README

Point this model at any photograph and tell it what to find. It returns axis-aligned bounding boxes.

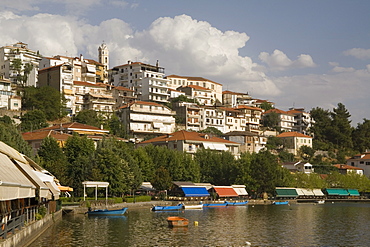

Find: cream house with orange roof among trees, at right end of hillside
[277,131,312,155]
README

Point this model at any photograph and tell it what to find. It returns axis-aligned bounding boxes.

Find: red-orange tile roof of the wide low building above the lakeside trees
[141,130,238,144]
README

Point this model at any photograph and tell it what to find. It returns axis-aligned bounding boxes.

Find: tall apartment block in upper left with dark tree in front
[0,42,41,86]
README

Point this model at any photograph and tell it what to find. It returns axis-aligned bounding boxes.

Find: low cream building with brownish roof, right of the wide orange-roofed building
[224,131,267,153]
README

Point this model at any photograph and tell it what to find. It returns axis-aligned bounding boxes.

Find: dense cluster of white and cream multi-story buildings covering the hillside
[0,42,314,151]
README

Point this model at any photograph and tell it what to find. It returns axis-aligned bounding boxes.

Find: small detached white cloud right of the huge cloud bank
[259,50,316,71]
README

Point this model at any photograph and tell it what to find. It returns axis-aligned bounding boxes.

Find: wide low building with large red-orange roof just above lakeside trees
[137,130,240,157]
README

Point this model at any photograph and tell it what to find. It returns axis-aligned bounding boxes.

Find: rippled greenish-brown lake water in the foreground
[30,203,370,247]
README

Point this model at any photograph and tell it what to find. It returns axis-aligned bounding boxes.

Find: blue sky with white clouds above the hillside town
[0,0,370,127]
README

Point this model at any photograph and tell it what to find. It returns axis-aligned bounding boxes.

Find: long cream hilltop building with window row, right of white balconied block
[167,75,222,105]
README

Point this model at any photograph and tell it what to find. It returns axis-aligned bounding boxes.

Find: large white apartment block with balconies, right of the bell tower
[110,61,169,103]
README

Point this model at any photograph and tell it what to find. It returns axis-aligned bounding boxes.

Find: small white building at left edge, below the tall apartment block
[0,76,22,111]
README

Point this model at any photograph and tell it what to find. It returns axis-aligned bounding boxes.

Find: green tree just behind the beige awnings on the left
[37,137,68,184]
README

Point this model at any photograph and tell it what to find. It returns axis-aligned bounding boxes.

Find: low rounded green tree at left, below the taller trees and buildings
[20,110,49,132]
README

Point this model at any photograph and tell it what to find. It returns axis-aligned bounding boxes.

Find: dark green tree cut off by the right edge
[352,118,370,153]
